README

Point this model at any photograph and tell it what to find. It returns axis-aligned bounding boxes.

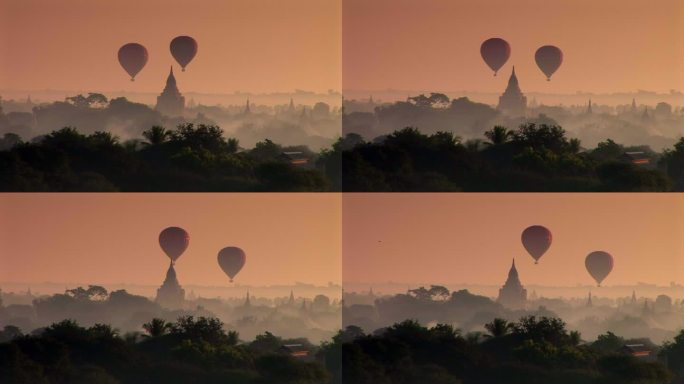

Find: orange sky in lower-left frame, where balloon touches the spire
[0,193,341,286]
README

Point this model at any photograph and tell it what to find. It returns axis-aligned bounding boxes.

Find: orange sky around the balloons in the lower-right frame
[342,193,684,286]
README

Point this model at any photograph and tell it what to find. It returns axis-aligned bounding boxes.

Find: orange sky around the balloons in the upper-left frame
[0,0,341,93]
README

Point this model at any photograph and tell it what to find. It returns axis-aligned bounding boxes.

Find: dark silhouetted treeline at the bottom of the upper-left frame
[0,124,329,191]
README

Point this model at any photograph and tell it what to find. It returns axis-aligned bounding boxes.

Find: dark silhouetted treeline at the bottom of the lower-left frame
[0,316,329,384]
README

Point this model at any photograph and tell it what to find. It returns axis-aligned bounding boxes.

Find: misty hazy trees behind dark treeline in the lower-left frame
[0,285,341,343]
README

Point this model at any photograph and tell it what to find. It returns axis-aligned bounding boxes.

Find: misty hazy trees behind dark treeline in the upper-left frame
[0,93,340,150]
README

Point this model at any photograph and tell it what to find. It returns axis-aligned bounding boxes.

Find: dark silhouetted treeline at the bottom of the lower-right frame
[329,316,684,384]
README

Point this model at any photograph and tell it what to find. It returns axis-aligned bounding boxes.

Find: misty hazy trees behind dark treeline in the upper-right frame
[342,92,684,151]
